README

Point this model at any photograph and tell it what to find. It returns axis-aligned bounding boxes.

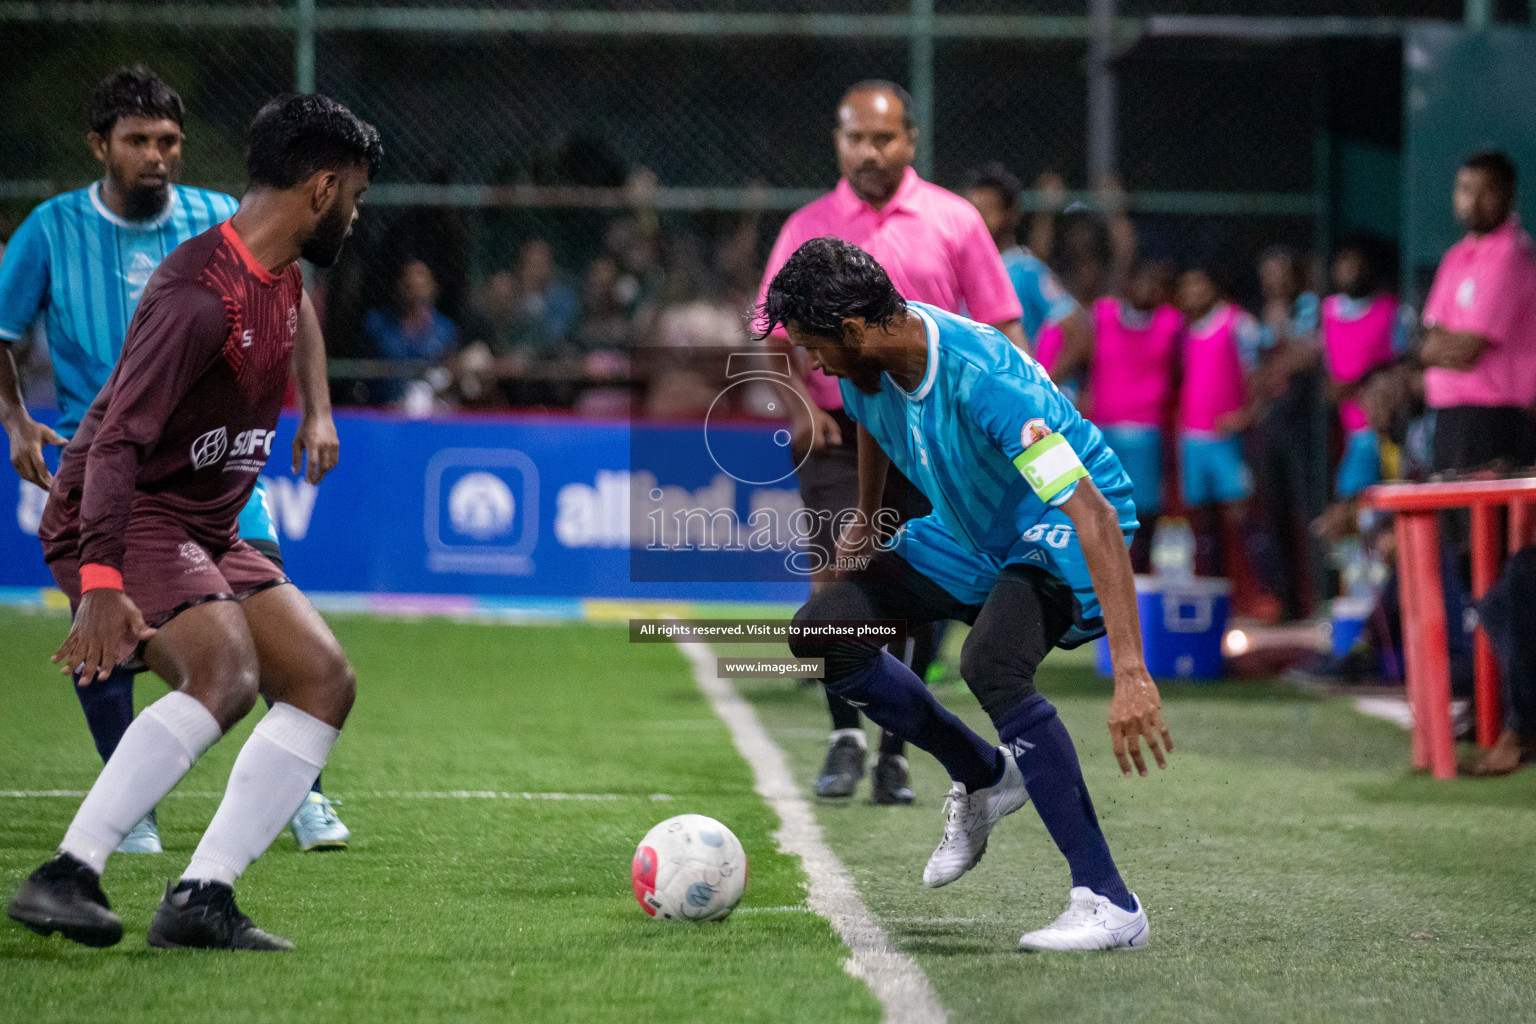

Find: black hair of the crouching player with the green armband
[756,235,906,339]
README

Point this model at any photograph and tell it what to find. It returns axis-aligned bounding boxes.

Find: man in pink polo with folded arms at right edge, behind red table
[1419,154,1536,470]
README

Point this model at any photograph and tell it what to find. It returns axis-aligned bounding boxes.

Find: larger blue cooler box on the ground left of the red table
[1095,576,1232,680]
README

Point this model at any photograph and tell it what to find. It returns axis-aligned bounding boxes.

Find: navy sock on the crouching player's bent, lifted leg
[833,651,1003,792]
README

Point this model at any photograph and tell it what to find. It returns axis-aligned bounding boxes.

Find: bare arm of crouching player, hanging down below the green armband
[1061,479,1174,775]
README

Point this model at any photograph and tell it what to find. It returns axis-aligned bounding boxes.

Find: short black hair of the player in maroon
[246,94,384,189]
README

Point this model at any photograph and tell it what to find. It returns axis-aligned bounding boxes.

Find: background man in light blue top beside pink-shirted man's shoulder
[962,163,1094,402]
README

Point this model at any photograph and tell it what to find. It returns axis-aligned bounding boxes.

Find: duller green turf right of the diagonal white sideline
[740,635,1536,1024]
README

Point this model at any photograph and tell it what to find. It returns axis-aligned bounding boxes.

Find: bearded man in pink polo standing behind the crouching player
[757,80,1028,803]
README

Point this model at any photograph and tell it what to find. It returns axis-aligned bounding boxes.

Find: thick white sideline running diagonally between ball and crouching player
[677,643,949,1024]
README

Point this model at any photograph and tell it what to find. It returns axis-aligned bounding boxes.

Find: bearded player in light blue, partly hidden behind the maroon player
[0,66,349,854]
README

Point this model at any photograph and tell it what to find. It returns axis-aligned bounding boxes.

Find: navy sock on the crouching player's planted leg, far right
[997,694,1135,910]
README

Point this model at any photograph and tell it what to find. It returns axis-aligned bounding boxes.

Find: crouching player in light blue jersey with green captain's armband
[759,238,1172,950]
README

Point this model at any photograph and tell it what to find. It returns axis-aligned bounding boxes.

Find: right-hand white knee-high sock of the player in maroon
[181,703,339,886]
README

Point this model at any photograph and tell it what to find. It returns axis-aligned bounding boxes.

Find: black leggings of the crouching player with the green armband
[790,551,1074,725]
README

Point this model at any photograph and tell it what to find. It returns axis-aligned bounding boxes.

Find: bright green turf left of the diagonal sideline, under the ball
[0,609,880,1024]
